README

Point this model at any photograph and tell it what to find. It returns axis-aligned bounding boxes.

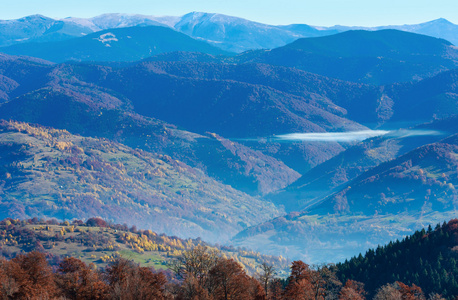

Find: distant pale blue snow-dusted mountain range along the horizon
[0,12,458,53]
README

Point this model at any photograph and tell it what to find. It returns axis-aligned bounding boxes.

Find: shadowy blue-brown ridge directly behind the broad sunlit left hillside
[0,53,299,194]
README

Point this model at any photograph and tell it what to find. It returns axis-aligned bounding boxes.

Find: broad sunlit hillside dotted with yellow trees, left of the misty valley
[0,122,280,241]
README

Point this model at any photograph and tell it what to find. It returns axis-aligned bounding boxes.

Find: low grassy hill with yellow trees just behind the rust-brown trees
[0,218,288,274]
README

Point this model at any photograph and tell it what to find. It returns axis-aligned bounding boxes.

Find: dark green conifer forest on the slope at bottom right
[337,219,458,299]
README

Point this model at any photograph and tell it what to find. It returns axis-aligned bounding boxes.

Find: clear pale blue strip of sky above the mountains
[0,0,458,26]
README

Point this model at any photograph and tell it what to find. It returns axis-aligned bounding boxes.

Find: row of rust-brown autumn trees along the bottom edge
[0,246,441,300]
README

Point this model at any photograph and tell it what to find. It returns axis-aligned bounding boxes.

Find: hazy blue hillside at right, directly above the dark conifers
[233,135,458,261]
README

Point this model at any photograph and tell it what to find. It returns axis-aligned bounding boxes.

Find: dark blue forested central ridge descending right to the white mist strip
[38,61,370,172]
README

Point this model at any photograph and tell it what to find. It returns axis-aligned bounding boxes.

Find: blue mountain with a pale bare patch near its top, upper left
[0,26,229,63]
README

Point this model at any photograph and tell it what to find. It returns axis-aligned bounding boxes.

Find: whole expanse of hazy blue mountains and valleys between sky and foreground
[0,13,458,262]
